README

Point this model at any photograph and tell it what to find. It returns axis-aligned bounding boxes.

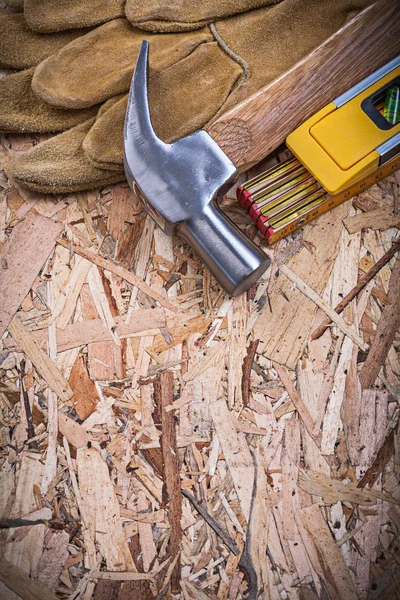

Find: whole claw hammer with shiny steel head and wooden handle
[124,0,400,296]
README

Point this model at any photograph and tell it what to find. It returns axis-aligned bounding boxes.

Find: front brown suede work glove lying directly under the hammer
[0,0,370,192]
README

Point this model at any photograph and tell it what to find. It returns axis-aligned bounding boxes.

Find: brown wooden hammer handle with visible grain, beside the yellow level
[206,0,400,171]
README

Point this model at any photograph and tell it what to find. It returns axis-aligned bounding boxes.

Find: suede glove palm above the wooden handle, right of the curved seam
[215,0,372,114]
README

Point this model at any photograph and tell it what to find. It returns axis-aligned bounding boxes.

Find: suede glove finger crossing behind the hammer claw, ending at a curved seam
[83,42,242,169]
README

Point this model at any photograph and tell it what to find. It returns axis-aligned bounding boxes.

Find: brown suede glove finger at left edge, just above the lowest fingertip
[0,68,99,133]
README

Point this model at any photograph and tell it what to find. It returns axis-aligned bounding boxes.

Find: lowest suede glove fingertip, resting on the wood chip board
[8,118,125,194]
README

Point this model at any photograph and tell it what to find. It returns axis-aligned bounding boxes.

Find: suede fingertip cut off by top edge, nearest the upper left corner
[24,0,125,33]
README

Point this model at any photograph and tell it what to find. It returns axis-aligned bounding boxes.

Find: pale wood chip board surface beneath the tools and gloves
[0,136,400,600]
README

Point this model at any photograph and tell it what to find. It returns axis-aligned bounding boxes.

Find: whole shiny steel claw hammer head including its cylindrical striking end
[124,41,270,296]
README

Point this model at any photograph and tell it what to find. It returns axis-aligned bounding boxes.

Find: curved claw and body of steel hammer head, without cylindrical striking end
[124,41,237,235]
